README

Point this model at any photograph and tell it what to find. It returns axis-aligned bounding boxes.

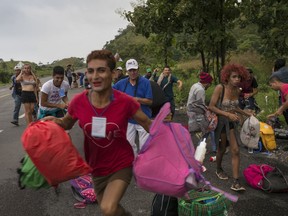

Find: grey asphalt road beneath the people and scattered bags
[0,79,288,216]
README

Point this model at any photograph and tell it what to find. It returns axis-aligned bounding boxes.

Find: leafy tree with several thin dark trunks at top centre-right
[176,0,240,77]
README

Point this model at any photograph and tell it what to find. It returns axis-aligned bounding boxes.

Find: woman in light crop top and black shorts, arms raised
[16,64,38,126]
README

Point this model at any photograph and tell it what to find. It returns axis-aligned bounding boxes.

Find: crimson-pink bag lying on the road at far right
[243,164,274,190]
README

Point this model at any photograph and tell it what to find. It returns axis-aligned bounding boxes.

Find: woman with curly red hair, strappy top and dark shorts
[209,64,251,191]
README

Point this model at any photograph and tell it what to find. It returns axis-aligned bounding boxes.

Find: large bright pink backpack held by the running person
[133,103,237,201]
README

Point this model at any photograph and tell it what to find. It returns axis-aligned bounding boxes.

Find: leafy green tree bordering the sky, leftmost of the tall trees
[124,0,182,65]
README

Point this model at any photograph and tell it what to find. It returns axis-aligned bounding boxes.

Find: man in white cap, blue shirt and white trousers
[113,59,153,155]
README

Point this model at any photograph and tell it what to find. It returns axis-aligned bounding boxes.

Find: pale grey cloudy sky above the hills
[0,0,135,64]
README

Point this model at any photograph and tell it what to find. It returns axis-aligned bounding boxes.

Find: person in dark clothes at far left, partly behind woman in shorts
[9,65,22,126]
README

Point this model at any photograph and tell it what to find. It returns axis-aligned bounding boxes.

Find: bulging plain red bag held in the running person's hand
[21,121,92,186]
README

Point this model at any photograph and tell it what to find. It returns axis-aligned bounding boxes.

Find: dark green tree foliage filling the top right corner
[241,0,288,59]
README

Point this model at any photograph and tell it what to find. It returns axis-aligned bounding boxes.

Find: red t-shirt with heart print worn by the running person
[68,90,140,176]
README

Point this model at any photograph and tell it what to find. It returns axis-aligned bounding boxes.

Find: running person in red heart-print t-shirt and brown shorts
[43,50,151,216]
